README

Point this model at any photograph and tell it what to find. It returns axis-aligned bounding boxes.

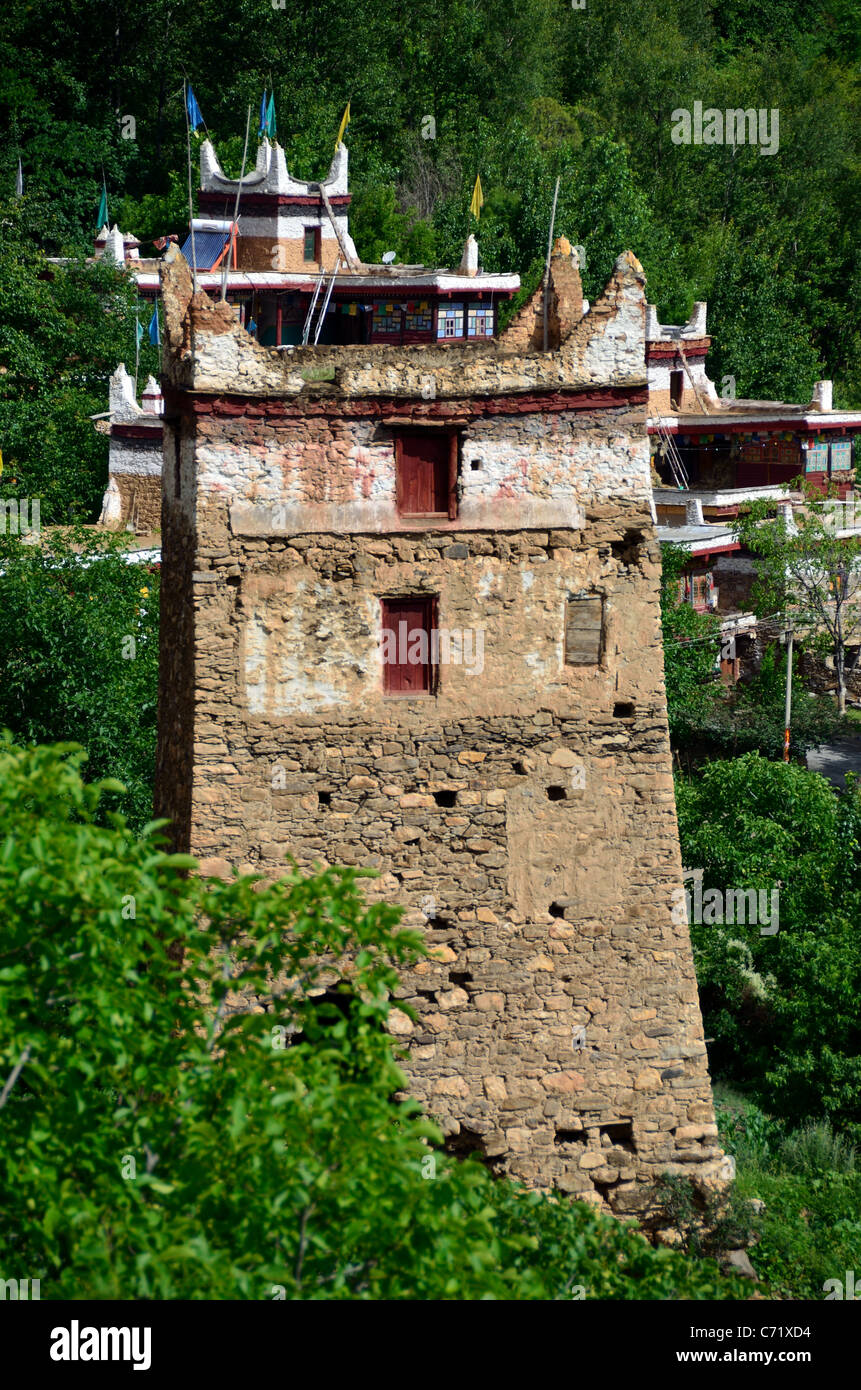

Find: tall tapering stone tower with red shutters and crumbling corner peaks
[157,247,725,1212]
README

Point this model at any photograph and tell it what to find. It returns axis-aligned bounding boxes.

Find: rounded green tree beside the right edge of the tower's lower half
[676,753,861,1137]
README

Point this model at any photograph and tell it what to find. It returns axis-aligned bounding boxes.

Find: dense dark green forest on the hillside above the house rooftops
[0,0,861,406]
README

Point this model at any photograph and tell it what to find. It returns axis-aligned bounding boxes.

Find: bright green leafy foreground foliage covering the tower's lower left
[0,742,739,1300]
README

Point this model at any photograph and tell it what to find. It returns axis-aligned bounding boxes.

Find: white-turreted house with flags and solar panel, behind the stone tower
[95,138,520,525]
